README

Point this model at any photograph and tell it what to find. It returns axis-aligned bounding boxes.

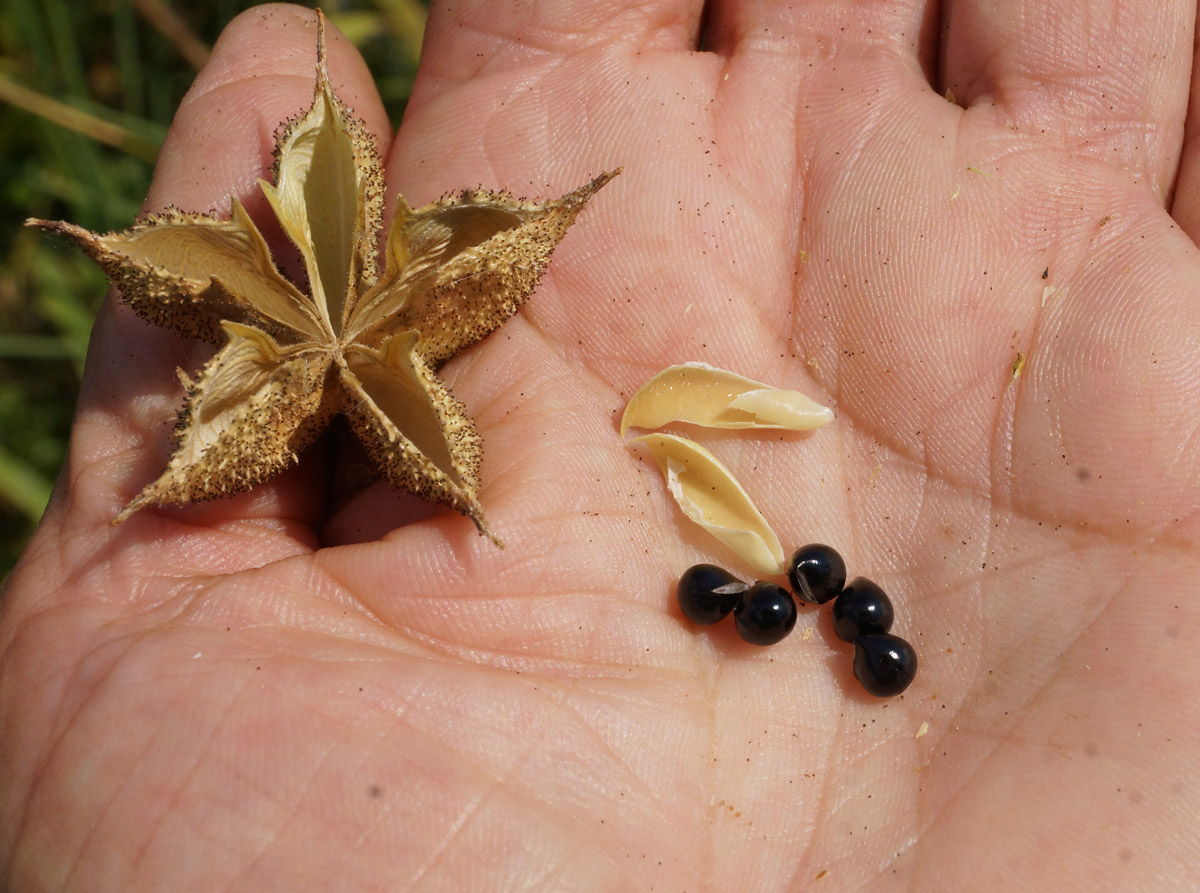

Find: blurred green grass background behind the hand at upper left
[0,0,427,580]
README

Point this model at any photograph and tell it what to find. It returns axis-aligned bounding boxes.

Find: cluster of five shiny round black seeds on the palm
[676,543,917,697]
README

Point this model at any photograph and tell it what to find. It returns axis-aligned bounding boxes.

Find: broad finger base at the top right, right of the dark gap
[944,0,1195,200]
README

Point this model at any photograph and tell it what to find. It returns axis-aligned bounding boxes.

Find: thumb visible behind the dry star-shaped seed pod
[58,5,389,544]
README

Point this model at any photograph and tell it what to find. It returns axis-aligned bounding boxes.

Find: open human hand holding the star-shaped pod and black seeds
[0,0,1200,891]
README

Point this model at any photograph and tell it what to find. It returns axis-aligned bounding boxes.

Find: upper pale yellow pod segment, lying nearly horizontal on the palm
[620,362,833,437]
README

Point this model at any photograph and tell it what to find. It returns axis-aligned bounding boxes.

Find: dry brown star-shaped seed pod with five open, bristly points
[29,13,618,543]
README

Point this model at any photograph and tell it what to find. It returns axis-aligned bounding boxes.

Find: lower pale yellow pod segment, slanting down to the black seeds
[630,434,784,575]
